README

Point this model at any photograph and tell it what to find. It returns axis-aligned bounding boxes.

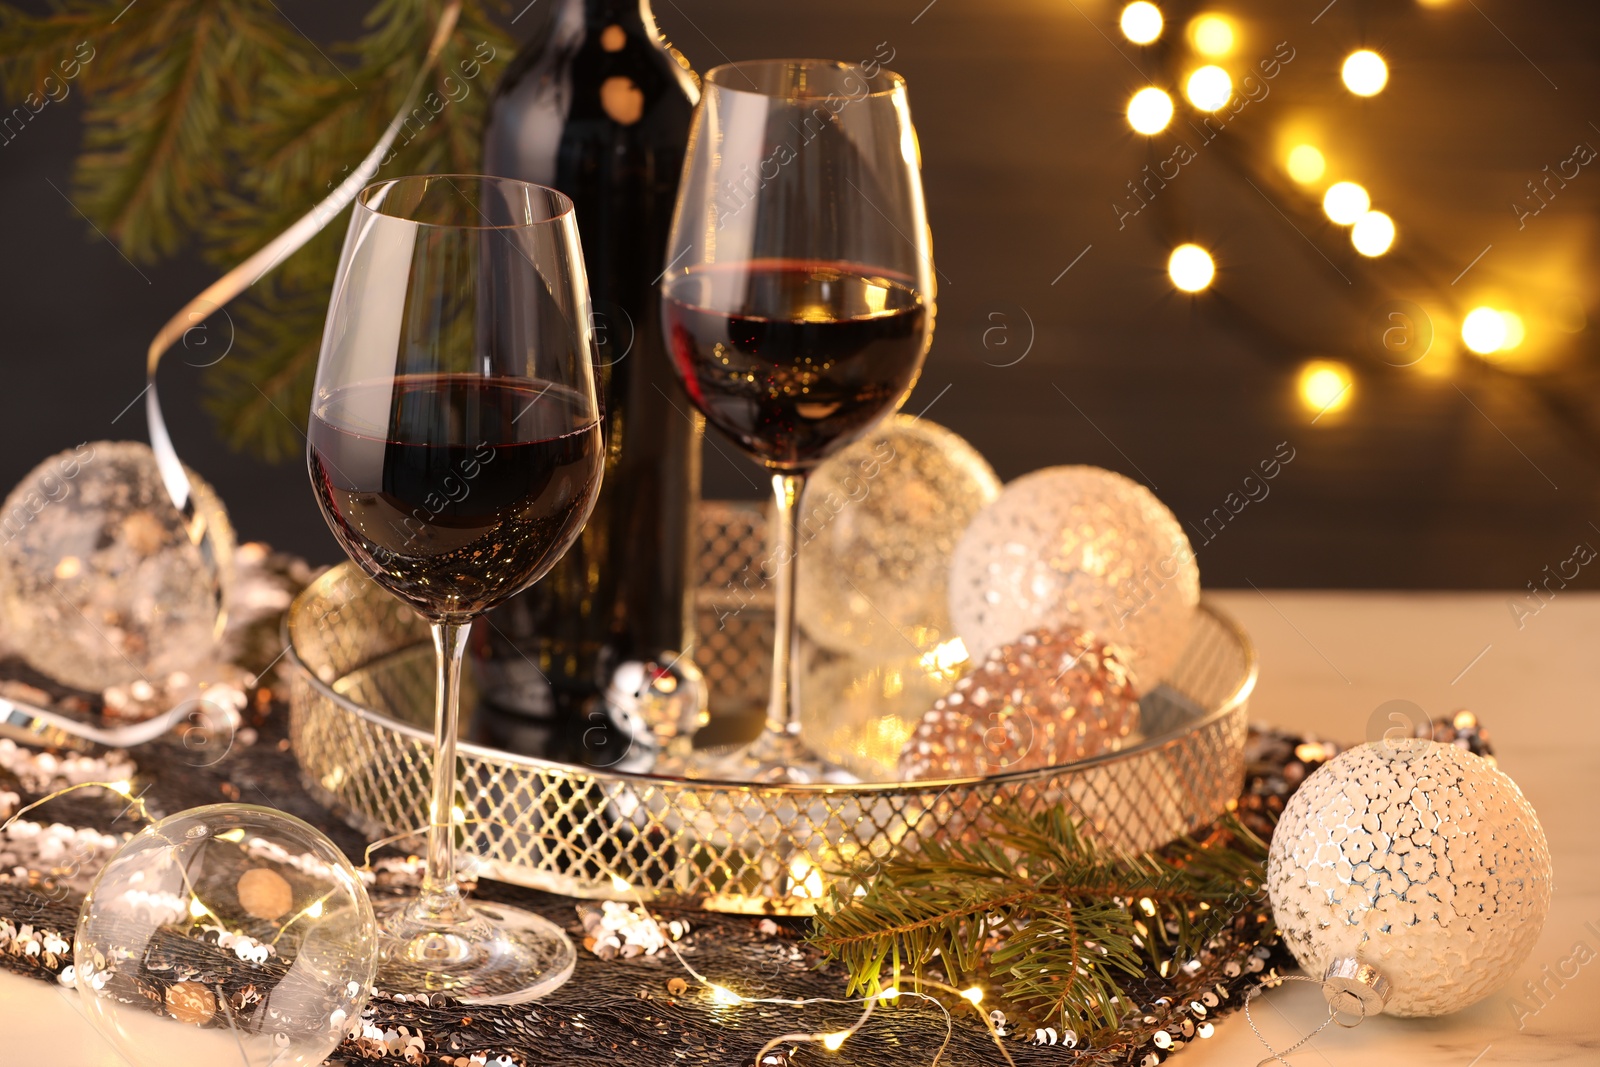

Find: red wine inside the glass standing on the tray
[662,259,928,470]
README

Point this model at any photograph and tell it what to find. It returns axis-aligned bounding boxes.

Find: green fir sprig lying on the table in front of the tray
[811,808,1266,1030]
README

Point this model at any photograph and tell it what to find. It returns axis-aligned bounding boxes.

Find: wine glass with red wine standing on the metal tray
[661,59,934,782]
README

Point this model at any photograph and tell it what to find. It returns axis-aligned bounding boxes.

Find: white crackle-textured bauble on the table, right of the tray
[1267,741,1550,1016]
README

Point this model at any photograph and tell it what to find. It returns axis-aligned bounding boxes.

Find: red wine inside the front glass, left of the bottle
[307,374,603,619]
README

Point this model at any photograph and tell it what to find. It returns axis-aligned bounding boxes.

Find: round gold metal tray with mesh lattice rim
[286,502,1256,915]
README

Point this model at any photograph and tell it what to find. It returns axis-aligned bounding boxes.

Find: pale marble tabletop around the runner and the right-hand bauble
[0,590,1600,1067]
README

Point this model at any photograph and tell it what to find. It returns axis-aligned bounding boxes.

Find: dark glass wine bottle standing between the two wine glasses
[472,0,701,766]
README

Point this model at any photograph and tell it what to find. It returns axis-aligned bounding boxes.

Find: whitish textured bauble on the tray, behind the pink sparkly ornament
[950,467,1200,694]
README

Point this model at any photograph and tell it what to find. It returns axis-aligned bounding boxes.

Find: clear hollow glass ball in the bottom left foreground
[72,805,378,1067]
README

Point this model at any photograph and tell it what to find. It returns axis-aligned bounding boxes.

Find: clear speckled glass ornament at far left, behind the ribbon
[0,442,234,691]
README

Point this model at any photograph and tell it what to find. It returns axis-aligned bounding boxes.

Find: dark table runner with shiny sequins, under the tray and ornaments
[0,704,1388,1067]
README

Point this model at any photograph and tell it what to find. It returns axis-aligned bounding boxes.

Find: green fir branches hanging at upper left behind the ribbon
[0,0,515,459]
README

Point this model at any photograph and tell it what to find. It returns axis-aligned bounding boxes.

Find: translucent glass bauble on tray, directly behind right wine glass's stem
[797,414,1000,659]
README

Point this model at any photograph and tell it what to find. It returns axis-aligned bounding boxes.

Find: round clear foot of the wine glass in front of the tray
[374,897,578,1005]
